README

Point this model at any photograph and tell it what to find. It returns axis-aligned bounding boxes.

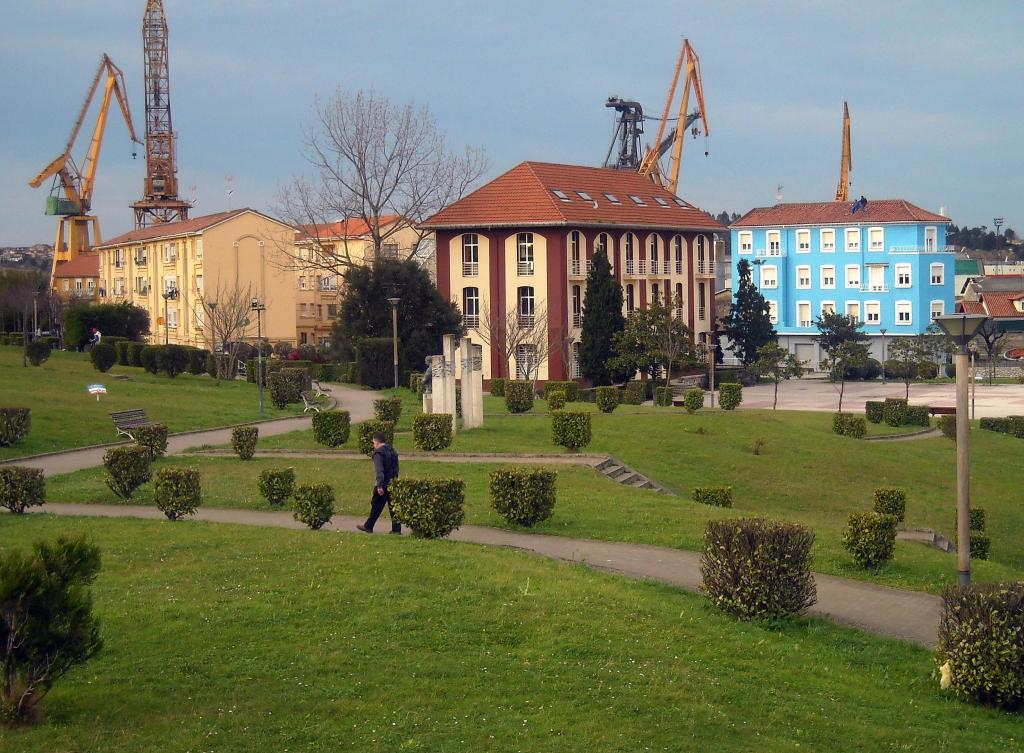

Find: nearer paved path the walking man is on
[38,503,941,649]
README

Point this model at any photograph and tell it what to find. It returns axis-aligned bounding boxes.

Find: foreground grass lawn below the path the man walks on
[0,515,1022,753]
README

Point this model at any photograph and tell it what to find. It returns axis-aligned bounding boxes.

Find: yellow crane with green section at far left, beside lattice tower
[29,54,141,280]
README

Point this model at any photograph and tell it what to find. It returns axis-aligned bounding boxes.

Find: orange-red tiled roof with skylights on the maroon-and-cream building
[422,162,724,231]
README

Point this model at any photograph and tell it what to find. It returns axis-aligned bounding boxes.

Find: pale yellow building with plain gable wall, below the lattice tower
[96,209,299,348]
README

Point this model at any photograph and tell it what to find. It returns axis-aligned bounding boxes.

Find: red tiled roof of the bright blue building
[729,199,951,227]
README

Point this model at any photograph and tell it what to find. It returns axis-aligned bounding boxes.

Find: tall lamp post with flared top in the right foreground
[935,313,988,586]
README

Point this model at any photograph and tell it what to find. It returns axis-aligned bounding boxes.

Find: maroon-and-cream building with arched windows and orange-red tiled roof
[423,162,725,381]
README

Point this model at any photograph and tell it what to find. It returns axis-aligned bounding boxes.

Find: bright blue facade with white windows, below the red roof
[731,216,955,339]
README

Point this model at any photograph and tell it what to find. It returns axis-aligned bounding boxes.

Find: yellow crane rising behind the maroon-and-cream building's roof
[640,39,711,194]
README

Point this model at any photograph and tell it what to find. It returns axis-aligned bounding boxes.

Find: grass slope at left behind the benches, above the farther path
[0,346,301,460]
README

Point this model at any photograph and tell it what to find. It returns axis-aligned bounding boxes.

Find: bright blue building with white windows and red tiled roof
[730,199,955,369]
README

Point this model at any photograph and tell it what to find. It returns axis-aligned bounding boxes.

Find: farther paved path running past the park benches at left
[0,384,380,475]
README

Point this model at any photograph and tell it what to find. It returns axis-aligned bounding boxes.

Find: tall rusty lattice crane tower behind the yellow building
[131,0,191,227]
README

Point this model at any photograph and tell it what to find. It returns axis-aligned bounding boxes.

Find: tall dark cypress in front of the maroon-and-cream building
[580,251,626,385]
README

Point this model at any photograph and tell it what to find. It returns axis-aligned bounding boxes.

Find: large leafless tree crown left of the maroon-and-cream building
[275,89,488,275]
